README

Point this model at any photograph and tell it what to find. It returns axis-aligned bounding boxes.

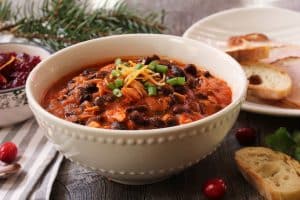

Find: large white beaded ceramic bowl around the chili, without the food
[26,34,247,184]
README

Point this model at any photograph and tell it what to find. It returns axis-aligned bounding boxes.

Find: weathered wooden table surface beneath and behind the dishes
[51,0,300,200]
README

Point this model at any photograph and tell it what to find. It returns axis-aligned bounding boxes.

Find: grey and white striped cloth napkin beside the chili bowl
[0,118,63,200]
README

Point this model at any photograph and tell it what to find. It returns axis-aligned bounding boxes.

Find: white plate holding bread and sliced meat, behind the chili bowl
[183,7,300,116]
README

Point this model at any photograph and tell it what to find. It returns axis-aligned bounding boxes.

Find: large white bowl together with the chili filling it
[26,34,247,184]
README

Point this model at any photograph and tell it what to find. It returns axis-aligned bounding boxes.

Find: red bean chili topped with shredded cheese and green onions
[43,55,232,130]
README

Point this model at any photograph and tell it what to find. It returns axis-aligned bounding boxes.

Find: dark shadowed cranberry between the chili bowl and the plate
[235,127,256,146]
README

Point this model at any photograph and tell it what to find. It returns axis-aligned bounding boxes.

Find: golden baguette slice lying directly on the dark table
[235,147,300,200]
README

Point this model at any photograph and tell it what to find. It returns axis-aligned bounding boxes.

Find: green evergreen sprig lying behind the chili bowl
[0,0,165,50]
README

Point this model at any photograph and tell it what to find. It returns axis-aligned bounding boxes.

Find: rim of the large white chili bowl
[25,33,247,137]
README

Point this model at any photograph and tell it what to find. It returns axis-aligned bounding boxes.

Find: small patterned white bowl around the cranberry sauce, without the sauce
[0,43,50,127]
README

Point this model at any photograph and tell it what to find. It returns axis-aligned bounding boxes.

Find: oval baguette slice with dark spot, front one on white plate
[241,62,292,100]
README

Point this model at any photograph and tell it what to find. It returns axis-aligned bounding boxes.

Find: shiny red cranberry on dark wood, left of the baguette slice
[202,178,226,199]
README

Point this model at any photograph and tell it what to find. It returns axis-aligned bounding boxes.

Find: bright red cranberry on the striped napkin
[0,142,18,163]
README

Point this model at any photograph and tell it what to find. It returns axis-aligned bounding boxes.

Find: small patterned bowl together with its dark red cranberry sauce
[0,43,50,127]
